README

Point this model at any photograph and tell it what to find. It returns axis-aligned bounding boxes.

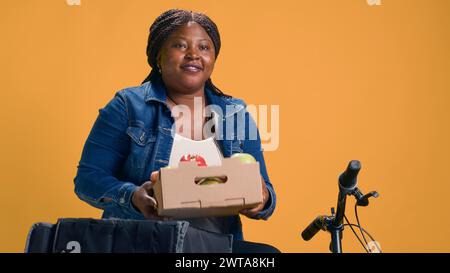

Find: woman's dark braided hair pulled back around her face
[142,9,231,97]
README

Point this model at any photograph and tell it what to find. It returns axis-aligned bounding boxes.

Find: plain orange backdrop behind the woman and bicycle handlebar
[0,0,450,252]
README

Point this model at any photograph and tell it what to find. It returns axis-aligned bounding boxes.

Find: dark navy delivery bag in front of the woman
[25,218,233,253]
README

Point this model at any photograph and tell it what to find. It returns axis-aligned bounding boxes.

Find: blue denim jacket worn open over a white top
[74,77,276,240]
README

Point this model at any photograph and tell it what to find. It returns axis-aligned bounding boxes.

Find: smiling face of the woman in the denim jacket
[158,22,215,94]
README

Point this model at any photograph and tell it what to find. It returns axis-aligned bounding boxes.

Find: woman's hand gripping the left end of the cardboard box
[131,171,164,220]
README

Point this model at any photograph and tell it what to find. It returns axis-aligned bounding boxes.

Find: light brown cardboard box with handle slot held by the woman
[154,158,263,219]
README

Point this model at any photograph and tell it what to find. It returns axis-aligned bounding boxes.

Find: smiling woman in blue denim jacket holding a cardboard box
[74,9,278,252]
